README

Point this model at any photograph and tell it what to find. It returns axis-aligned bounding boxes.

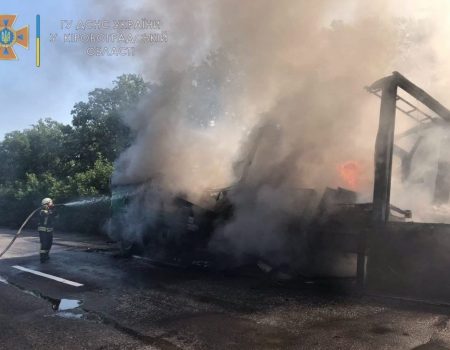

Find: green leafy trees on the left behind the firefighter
[0,74,149,228]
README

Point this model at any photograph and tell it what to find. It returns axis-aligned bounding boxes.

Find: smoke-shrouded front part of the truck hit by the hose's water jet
[111,180,231,261]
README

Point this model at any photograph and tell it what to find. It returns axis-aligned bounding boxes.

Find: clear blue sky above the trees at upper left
[0,0,144,139]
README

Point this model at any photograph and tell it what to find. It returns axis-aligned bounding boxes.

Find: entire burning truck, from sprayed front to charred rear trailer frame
[111,72,450,299]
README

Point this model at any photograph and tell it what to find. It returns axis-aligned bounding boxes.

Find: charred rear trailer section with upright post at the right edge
[314,72,450,302]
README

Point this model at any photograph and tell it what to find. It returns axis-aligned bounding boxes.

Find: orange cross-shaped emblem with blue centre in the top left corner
[0,15,30,60]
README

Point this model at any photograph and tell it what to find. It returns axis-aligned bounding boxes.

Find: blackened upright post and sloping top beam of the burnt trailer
[366,72,450,225]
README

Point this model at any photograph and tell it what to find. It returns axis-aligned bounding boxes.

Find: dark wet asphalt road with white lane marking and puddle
[0,230,450,349]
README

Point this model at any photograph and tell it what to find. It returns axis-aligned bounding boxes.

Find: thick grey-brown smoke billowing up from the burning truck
[110,0,450,262]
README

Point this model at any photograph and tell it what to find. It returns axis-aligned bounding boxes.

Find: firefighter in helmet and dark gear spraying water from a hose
[38,198,57,263]
